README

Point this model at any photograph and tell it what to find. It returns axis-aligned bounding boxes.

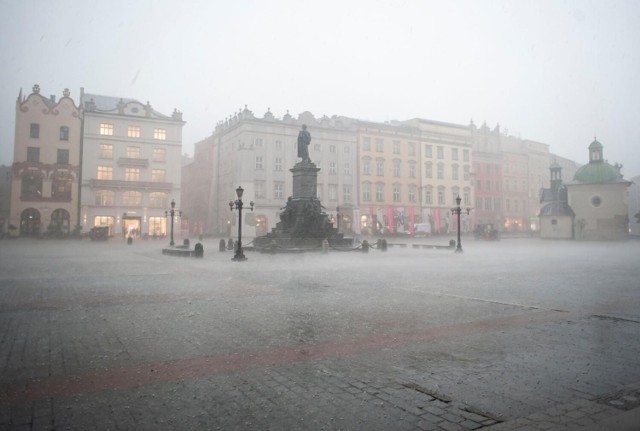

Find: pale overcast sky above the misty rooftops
[0,0,640,179]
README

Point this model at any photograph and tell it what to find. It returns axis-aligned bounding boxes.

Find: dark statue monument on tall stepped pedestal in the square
[253,124,353,252]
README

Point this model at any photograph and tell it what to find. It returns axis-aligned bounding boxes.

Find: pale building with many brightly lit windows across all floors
[81,90,185,238]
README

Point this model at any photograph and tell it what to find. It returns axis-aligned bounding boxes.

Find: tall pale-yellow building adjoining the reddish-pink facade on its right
[404,118,474,234]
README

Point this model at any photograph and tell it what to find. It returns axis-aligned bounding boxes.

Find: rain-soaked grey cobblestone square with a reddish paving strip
[0,239,640,431]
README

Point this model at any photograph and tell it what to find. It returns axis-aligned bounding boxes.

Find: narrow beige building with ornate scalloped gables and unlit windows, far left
[9,84,81,237]
